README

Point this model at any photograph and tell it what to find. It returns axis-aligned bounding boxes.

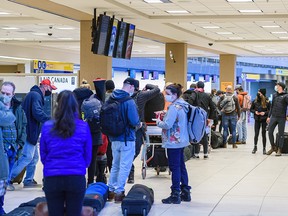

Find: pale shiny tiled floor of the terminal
[5,124,288,216]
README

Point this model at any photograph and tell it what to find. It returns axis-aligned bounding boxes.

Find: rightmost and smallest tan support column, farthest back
[219,54,236,91]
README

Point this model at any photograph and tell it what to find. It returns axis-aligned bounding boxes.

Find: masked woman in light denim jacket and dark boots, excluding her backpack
[156,84,191,204]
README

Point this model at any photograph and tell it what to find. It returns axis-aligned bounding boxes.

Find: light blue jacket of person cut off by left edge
[0,102,16,180]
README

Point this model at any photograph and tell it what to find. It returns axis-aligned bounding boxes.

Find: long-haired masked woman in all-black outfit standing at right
[250,89,271,155]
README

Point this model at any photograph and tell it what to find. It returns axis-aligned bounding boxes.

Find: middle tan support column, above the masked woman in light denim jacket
[165,43,187,90]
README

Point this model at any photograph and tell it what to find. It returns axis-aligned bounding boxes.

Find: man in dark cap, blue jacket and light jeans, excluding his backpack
[104,78,141,203]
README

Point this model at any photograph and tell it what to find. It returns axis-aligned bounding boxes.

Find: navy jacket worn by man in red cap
[22,85,50,145]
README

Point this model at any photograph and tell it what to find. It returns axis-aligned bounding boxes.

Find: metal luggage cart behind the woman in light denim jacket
[141,123,170,179]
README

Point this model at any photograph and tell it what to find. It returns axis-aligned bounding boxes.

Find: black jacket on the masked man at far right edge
[268,92,288,118]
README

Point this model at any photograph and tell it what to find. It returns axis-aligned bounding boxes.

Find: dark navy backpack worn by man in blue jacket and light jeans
[100,96,132,137]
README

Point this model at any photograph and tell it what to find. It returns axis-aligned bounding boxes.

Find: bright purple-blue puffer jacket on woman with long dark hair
[40,119,92,177]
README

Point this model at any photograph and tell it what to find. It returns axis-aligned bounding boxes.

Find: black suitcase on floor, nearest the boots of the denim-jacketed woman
[121,184,154,216]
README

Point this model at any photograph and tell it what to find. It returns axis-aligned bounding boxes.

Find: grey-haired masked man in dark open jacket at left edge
[1,82,27,190]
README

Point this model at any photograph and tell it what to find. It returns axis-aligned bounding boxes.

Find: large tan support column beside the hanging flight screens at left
[79,20,112,86]
